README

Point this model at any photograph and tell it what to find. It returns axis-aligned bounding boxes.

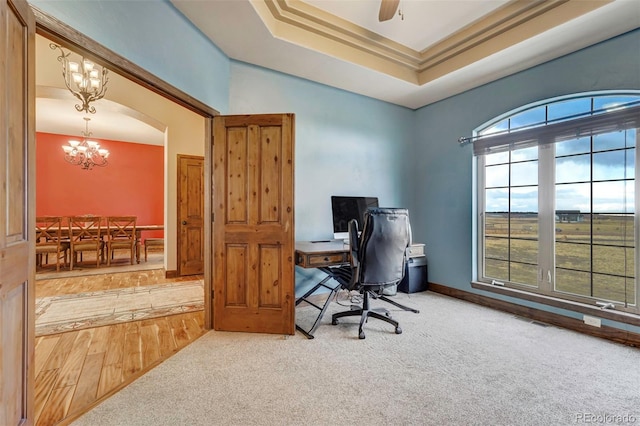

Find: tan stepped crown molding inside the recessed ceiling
[251,0,613,86]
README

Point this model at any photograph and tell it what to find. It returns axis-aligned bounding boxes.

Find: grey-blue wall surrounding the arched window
[410,30,640,332]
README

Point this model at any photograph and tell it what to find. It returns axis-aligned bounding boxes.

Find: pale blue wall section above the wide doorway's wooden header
[29,0,229,113]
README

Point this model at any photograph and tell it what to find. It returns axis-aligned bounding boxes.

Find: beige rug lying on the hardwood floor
[36,280,204,336]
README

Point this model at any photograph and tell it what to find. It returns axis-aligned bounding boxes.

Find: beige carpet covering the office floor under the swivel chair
[73,292,640,426]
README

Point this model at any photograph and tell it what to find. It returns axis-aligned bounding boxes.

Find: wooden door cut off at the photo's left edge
[0,0,35,425]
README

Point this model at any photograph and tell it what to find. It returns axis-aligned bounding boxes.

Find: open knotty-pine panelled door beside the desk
[212,114,295,334]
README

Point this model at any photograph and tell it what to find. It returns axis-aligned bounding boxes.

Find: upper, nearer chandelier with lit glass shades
[49,43,109,114]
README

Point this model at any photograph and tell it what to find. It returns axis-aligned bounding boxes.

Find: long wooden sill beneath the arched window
[471,281,640,327]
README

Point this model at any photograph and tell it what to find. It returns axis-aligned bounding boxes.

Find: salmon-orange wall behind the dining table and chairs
[36,133,164,238]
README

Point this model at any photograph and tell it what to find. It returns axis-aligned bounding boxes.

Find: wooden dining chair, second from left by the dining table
[69,215,104,271]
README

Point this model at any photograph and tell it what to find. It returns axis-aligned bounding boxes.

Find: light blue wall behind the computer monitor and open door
[230,61,414,240]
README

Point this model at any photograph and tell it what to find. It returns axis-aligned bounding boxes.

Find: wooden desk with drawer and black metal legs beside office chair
[295,240,350,339]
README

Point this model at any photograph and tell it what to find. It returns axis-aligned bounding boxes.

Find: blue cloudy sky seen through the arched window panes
[479,96,640,213]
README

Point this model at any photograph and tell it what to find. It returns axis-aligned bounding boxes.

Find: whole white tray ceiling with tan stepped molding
[172,0,640,109]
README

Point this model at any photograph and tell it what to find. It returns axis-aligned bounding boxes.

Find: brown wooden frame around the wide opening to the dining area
[30,5,220,330]
